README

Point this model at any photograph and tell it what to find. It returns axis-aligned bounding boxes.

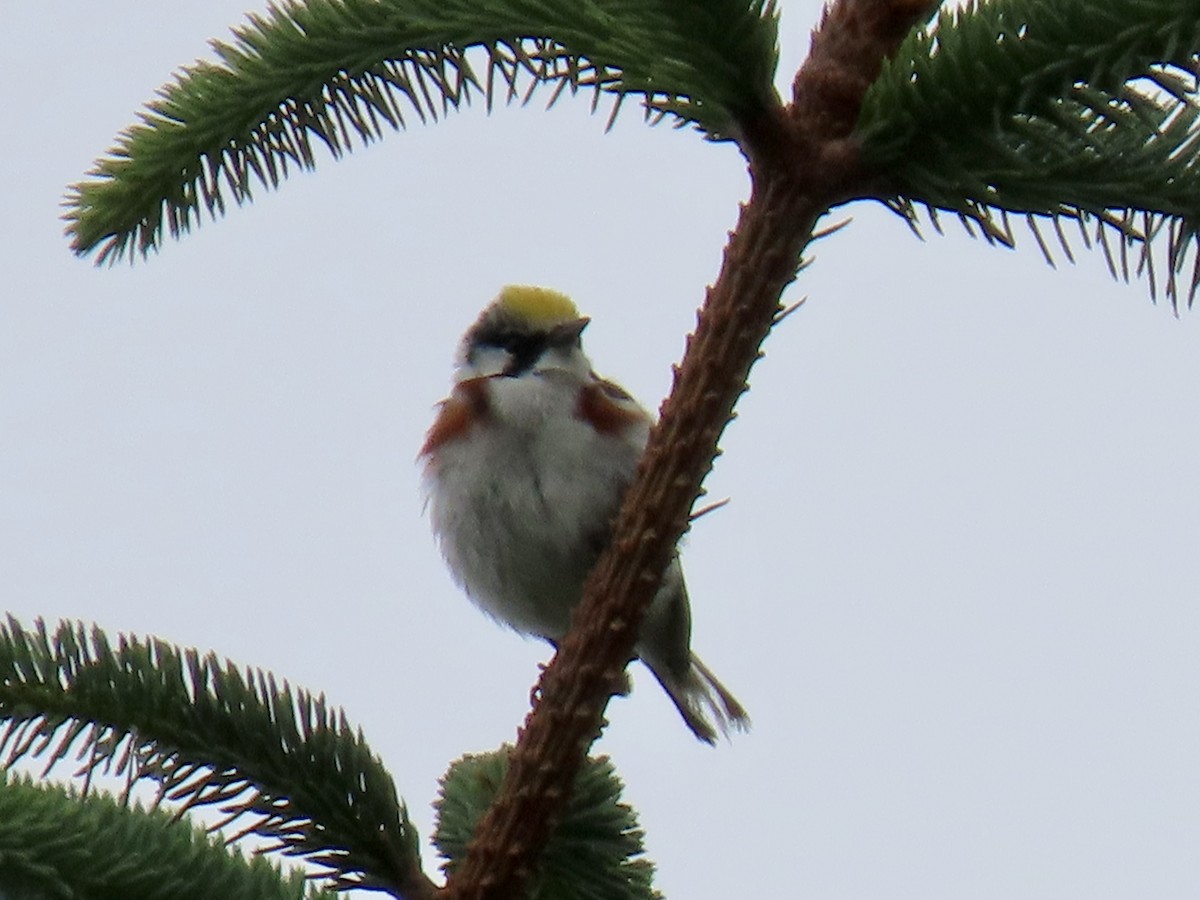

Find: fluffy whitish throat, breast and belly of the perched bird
[426,371,648,638]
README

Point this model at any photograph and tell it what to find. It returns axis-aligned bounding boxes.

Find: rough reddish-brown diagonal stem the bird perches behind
[448,0,937,900]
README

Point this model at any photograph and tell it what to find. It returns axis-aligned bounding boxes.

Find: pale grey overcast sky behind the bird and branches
[0,0,1200,900]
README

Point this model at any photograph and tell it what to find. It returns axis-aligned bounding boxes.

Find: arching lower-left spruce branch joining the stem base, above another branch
[0,616,433,898]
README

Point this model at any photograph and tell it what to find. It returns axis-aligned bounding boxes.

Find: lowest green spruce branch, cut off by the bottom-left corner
[0,769,335,900]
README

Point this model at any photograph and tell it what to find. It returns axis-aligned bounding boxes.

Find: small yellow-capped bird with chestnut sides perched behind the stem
[418,284,750,744]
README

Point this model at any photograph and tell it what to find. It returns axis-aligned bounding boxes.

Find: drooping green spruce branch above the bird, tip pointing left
[65,0,776,262]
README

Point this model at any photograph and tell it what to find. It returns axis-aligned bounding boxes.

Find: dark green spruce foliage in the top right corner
[857,0,1200,306]
